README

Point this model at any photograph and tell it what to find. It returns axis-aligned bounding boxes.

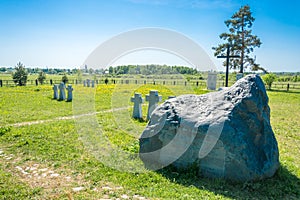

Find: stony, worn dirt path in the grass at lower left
[0,145,146,200]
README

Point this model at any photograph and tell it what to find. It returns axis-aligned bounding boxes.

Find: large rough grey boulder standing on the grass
[140,75,279,181]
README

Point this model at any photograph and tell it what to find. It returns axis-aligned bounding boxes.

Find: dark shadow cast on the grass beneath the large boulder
[158,165,300,199]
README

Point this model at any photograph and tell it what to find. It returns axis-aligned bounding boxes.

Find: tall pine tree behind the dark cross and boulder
[212,5,266,73]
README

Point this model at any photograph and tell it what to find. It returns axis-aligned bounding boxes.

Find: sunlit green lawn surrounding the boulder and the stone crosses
[0,85,300,199]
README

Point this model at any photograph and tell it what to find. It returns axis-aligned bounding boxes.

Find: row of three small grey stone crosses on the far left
[53,82,73,102]
